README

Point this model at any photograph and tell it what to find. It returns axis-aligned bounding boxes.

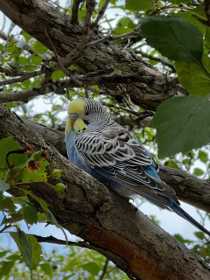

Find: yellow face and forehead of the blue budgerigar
[65,98,87,134]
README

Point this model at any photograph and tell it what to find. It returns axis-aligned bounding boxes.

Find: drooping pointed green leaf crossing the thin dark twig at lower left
[10,229,41,270]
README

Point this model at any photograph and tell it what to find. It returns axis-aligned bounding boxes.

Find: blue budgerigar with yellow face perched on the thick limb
[65,98,210,236]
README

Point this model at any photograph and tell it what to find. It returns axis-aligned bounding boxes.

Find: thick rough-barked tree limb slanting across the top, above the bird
[0,0,183,109]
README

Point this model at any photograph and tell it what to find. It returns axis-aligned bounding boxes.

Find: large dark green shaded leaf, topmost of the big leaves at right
[141,16,203,62]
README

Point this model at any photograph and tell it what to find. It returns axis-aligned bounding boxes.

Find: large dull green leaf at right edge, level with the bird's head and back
[153,96,210,157]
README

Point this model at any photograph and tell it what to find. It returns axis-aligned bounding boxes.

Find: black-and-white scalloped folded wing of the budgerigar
[75,128,162,190]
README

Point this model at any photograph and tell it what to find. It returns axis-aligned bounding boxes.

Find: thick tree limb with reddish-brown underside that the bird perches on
[0,108,210,280]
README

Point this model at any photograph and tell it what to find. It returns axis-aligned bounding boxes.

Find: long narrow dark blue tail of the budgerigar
[169,200,210,237]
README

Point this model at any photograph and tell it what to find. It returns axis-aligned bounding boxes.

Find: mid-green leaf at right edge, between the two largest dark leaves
[176,62,210,96]
